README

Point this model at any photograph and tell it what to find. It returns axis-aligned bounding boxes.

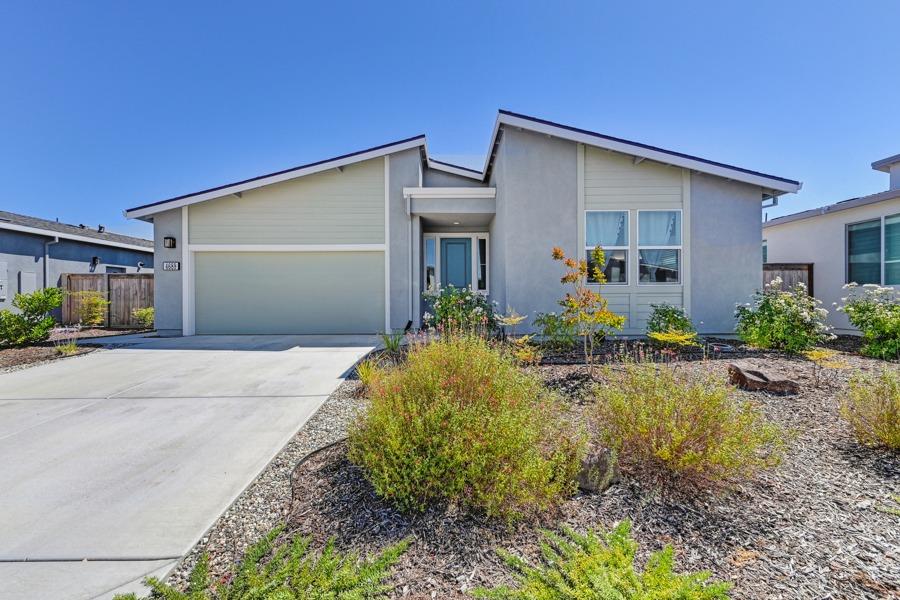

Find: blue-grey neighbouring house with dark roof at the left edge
[0,211,153,309]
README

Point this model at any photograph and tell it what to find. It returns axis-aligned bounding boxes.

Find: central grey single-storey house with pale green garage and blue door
[125,111,800,335]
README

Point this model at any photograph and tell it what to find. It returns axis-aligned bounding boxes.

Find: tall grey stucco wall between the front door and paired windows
[491,128,578,323]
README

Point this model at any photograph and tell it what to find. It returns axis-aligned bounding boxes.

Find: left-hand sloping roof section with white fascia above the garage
[125,135,425,218]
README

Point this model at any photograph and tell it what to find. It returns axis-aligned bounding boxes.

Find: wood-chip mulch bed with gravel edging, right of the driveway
[165,340,900,599]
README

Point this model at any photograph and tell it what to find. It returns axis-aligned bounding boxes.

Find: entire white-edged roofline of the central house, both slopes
[125,109,802,218]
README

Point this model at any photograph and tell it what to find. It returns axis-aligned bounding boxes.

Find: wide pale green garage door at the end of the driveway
[194,252,384,334]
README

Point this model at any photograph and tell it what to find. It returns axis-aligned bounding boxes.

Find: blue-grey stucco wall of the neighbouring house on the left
[0,230,153,317]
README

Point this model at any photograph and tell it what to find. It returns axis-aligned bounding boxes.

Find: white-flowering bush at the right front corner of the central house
[735,278,834,353]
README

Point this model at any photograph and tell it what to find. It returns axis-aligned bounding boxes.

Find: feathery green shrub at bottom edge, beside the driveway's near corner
[113,528,409,600]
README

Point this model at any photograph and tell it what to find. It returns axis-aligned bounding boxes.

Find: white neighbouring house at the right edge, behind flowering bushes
[763,154,900,333]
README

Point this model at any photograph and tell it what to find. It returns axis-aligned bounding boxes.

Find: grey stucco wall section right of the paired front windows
[691,173,762,334]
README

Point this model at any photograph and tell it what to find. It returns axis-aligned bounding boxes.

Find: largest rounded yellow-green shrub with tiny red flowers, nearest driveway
[349,335,584,520]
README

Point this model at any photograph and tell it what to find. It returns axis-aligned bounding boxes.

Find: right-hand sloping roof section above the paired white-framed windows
[483,109,803,195]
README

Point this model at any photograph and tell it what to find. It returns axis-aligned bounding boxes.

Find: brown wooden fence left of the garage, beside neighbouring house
[61,273,153,329]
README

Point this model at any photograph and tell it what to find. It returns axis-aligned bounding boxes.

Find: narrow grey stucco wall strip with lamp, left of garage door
[153,208,187,335]
